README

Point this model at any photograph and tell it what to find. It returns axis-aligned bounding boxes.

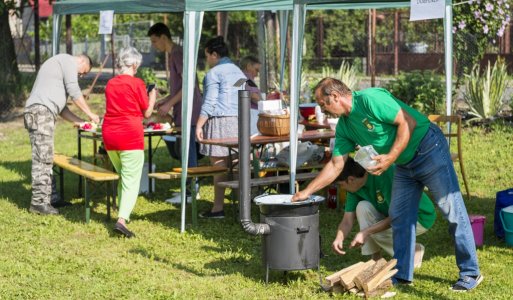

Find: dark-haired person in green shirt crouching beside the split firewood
[332,157,436,268]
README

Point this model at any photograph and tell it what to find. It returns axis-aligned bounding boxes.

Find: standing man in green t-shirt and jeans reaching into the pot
[292,78,483,292]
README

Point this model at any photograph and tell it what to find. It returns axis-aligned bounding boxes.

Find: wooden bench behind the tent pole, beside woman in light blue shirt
[148,166,228,226]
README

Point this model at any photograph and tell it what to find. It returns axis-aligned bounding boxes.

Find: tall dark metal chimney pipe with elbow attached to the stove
[239,90,271,235]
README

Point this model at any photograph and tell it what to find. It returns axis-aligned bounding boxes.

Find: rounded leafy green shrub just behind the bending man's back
[385,71,445,115]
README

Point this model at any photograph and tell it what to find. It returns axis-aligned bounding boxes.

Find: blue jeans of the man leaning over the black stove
[389,124,480,281]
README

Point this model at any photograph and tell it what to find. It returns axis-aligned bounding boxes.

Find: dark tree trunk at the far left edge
[0,5,20,114]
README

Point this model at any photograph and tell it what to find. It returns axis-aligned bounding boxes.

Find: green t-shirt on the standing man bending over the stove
[333,88,430,164]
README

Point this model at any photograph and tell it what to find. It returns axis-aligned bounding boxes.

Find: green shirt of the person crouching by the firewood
[345,166,436,229]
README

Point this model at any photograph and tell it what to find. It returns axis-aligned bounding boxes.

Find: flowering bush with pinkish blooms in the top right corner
[452,0,512,78]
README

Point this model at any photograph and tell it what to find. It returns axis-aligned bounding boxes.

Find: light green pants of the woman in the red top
[107,150,144,221]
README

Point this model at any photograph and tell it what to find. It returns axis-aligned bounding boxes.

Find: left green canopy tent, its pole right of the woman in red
[52,0,292,232]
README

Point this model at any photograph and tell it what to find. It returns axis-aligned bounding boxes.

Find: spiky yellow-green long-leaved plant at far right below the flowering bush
[465,59,508,119]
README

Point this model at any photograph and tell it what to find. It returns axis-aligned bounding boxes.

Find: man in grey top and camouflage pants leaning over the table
[24,54,99,215]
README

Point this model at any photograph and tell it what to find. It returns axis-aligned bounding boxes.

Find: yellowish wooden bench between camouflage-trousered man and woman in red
[53,154,119,223]
